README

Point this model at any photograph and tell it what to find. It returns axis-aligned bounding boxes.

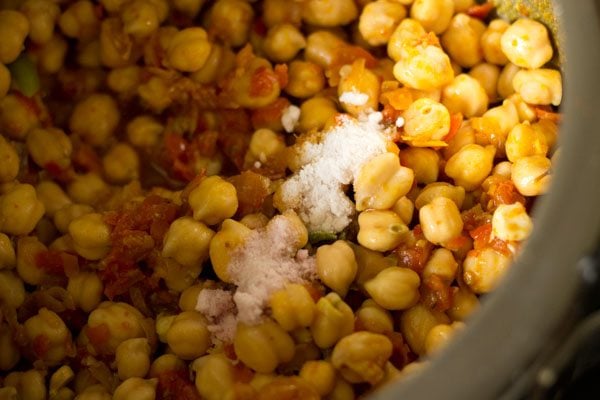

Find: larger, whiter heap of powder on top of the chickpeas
[281,112,387,232]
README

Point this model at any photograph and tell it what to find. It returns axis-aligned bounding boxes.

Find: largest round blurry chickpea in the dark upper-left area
[69,93,120,146]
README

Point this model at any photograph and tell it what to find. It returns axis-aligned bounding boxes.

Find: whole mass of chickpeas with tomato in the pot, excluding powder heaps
[0,0,562,400]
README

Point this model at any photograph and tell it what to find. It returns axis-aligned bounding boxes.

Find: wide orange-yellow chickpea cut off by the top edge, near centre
[302,0,358,26]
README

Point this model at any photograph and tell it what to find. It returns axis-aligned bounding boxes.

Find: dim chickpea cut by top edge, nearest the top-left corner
[20,0,60,44]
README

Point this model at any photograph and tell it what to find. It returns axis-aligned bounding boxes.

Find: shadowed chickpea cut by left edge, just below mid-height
[0,184,45,235]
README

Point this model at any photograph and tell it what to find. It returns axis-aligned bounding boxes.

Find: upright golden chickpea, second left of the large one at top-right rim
[442,13,485,68]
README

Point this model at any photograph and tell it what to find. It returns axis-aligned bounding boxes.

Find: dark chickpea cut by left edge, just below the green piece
[0,94,40,140]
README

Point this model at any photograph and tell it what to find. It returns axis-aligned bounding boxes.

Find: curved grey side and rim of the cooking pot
[372,0,600,400]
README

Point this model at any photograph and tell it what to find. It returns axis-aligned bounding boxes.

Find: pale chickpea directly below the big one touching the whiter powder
[357,210,408,251]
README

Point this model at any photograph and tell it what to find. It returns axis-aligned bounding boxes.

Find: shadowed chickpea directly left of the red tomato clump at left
[68,213,111,260]
